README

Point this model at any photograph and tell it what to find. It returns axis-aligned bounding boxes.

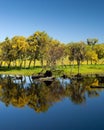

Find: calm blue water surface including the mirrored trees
[0,75,104,130]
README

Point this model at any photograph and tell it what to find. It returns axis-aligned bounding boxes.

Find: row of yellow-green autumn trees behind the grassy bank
[0,31,104,68]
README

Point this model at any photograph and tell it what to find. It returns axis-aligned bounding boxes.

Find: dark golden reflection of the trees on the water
[0,75,104,112]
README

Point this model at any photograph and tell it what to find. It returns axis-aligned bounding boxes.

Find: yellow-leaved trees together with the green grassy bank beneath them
[0,31,104,75]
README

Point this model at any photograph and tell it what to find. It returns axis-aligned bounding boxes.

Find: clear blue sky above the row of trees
[0,0,104,43]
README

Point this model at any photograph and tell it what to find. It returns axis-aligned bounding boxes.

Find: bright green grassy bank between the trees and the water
[0,65,104,76]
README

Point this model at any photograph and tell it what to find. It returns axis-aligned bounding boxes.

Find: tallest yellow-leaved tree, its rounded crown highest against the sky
[27,31,50,67]
